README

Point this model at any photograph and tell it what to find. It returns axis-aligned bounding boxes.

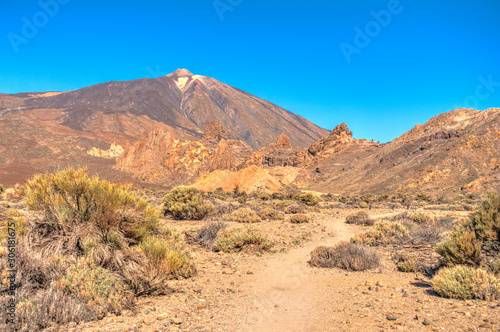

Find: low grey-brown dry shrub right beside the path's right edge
[309,242,380,271]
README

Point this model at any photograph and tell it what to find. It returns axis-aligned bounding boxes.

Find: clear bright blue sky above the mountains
[0,0,500,142]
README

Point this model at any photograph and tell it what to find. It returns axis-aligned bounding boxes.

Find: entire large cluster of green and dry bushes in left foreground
[0,168,194,330]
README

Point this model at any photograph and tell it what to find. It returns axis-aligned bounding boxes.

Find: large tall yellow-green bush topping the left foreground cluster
[26,168,158,255]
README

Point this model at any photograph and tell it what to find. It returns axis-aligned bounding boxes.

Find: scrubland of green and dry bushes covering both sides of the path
[0,168,500,331]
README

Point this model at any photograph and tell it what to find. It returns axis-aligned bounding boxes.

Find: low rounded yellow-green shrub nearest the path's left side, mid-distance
[214,227,271,252]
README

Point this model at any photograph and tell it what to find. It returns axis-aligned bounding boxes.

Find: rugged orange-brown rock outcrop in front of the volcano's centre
[117,122,251,184]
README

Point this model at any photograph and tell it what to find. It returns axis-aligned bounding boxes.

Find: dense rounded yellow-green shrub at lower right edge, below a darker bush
[432,265,500,301]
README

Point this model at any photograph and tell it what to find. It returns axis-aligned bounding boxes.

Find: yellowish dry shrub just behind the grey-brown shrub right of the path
[351,220,410,246]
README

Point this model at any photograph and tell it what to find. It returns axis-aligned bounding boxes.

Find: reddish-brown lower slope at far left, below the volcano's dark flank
[0,109,189,185]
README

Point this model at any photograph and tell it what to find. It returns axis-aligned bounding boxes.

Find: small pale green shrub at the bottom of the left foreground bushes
[58,259,131,317]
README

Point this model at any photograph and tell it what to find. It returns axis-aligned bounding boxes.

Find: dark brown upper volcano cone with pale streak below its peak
[20,70,327,149]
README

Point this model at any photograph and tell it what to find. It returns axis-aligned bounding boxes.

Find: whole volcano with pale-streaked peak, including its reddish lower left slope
[0,70,327,184]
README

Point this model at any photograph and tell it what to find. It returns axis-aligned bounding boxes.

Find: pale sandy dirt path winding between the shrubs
[237,215,357,331]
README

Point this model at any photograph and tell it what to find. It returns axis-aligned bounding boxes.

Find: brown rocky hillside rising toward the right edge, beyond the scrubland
[300,108,500,195]
